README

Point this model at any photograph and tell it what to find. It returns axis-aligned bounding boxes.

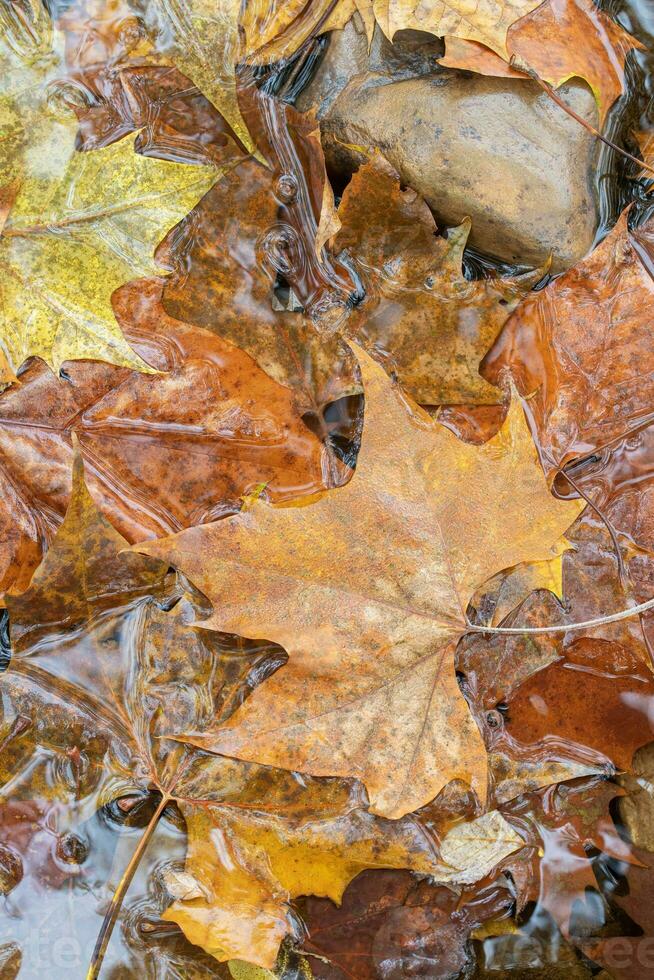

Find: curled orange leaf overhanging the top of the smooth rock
[439,0,642,125]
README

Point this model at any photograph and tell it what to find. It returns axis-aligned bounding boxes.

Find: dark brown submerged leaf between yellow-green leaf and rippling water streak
[162,156,357,415]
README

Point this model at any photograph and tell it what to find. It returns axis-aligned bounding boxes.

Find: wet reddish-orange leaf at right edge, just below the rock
[480,213,654,475]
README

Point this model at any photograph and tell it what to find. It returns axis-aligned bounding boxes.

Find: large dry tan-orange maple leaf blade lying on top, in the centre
[137,349,579,817]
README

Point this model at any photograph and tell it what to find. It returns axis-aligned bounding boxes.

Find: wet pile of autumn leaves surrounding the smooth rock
[0,0,654,980]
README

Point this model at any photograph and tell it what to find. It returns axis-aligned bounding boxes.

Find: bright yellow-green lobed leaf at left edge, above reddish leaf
[0,123,218,378]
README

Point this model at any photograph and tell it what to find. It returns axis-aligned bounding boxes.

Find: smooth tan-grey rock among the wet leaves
[298,21,598,270]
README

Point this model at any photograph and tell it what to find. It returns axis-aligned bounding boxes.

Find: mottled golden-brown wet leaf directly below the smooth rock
[333,154,545,405]
